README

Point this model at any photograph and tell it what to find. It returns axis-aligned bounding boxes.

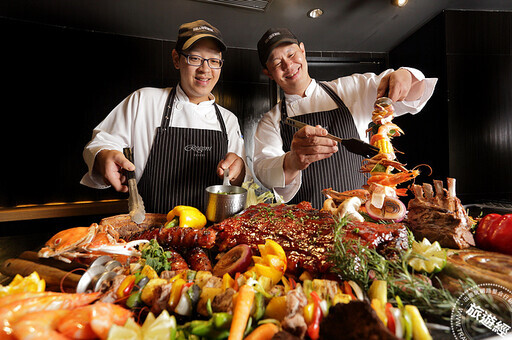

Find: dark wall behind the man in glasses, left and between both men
[0,19,271,207]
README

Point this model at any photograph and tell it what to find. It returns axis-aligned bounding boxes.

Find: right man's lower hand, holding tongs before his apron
[283,125,338,184]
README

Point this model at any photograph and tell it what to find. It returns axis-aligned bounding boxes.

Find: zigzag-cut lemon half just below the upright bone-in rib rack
[409,238,447,273]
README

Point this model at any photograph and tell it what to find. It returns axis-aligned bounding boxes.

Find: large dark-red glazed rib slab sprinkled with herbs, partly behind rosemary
[213,202,407,275]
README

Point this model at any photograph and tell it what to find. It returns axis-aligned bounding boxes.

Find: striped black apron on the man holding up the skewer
[280,83,366,209]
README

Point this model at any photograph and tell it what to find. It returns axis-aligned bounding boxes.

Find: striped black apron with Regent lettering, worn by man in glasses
[138,88,228,214]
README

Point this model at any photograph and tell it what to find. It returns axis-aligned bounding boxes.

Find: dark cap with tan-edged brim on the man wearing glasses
[175,20,227,52]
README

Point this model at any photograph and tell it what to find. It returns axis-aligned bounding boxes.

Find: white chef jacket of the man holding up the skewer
[253,68,437,202]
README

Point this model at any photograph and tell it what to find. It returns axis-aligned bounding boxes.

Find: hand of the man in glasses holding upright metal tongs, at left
[94,150,135,192]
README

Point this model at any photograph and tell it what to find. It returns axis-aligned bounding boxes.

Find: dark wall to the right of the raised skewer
[389,10,512,204]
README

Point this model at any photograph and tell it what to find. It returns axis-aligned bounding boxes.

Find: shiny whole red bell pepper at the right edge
[475,214,512,255]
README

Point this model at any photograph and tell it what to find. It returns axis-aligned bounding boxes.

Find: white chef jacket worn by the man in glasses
[80,85,247,189]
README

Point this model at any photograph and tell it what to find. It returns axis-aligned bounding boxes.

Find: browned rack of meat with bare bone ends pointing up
[407,178,475,249]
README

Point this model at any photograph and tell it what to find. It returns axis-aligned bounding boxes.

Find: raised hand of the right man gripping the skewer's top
[377,68,425,102]
